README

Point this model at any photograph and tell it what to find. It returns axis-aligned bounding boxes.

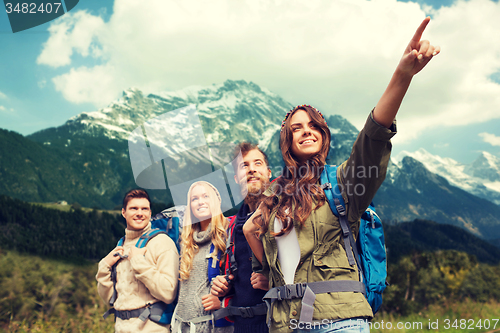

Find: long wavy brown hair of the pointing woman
[258,105,331,236]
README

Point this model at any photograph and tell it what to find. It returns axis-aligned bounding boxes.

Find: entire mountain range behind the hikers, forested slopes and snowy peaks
[0,80,500,239]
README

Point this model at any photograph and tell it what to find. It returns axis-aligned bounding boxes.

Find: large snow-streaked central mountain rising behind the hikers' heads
[24,80,358,205]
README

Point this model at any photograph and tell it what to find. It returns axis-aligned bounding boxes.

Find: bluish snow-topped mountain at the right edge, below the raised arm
[374,156,500,239]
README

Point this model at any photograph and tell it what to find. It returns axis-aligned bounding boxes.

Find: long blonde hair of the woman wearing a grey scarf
[179,181,228,280]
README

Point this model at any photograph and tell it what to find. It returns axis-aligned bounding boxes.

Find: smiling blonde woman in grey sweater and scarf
[172,181,233,333]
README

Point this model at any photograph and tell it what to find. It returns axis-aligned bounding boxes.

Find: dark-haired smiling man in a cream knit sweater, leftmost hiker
[96,189,179,333]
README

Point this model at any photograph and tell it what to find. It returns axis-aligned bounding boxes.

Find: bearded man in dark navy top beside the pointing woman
[211,142,271,333]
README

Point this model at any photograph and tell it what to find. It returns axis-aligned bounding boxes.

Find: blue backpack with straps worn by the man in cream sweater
[103,206,185,324]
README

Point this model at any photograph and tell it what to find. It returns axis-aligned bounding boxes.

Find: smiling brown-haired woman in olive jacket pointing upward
[243,18,440,333]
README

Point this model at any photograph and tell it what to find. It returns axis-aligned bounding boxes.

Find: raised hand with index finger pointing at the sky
[397,17,441,76]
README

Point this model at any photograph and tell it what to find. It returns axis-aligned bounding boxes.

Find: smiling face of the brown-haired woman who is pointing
[290,110,323,163]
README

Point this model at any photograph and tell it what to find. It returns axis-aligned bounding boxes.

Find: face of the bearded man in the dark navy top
[234,149,271,197]
